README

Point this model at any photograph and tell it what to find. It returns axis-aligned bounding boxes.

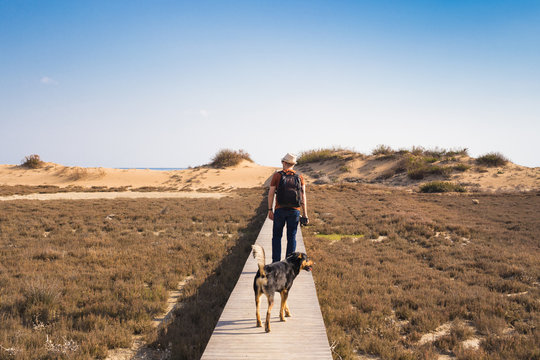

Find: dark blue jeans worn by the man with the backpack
[272,208,300,262]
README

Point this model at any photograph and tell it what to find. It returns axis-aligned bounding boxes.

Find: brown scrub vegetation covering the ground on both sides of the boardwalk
[0,184,540,360]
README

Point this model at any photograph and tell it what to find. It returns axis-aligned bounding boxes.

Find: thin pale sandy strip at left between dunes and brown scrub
[0,191,226,201]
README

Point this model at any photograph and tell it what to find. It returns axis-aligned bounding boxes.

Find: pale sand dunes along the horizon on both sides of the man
[0,153,540,197]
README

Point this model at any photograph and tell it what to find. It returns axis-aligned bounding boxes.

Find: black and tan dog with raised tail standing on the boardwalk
[252,245,313,332]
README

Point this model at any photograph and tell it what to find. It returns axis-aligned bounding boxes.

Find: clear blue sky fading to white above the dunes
[0,0,540,167]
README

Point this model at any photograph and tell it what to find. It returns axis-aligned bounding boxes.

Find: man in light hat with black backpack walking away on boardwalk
[268,153,309,262]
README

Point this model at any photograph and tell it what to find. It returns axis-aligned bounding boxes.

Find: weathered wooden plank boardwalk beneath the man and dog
[202,219,332,360]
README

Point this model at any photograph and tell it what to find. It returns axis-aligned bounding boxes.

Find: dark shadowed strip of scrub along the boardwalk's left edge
[149,193,267,359]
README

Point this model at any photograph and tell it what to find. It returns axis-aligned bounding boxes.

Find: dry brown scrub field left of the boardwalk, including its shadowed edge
[0,189,265,359]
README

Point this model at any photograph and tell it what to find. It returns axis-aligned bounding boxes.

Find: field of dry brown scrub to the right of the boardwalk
[304,185,540,359]
